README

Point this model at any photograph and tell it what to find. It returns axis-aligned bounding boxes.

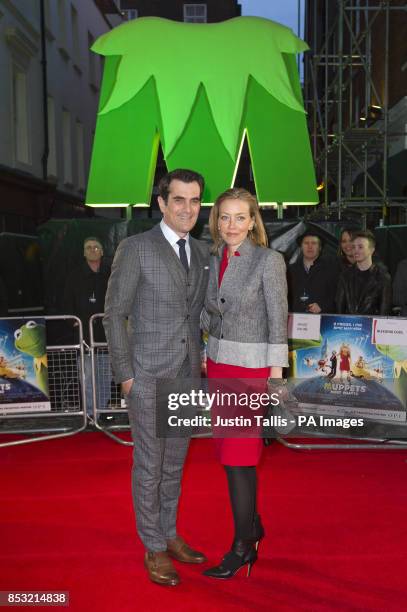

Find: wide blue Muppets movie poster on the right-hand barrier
[289,314,407,425]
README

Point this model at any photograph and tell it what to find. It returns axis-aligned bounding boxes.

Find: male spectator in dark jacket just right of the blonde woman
[287,229,339,314]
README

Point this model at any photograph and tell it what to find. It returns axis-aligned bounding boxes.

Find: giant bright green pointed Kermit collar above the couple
[92,17,308,159]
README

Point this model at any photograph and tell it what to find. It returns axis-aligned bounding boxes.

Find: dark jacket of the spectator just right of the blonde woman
[287,256,340,313]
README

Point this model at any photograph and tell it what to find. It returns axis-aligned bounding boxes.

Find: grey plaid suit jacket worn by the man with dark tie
[103,225,209,386]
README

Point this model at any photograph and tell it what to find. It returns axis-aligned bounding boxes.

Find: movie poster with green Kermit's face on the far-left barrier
[0,317,51,415]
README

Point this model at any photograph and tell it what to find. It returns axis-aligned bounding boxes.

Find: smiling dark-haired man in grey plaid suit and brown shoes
[104,170,209,586]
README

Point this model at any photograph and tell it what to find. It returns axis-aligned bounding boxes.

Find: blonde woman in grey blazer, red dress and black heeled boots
[202,188,288,578]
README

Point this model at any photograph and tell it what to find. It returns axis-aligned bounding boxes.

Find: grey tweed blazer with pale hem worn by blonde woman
[201,239,288,368]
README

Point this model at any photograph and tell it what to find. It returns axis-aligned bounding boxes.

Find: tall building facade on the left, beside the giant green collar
[0,0,123,233]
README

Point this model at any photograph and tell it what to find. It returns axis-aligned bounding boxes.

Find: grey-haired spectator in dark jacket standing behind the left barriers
[63,236,111,414]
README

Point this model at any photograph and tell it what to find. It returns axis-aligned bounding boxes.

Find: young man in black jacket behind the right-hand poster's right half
[336,231,392,315]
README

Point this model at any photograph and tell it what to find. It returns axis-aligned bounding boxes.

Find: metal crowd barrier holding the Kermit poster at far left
[0,315,87,448]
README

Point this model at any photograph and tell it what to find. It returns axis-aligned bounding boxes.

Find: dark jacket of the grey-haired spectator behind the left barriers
[63,261,110,344]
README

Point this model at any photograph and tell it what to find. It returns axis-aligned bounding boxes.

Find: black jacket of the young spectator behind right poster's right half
[336,264,392,315]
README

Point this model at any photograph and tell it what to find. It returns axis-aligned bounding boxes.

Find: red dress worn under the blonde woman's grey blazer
[207,247,270,465]
